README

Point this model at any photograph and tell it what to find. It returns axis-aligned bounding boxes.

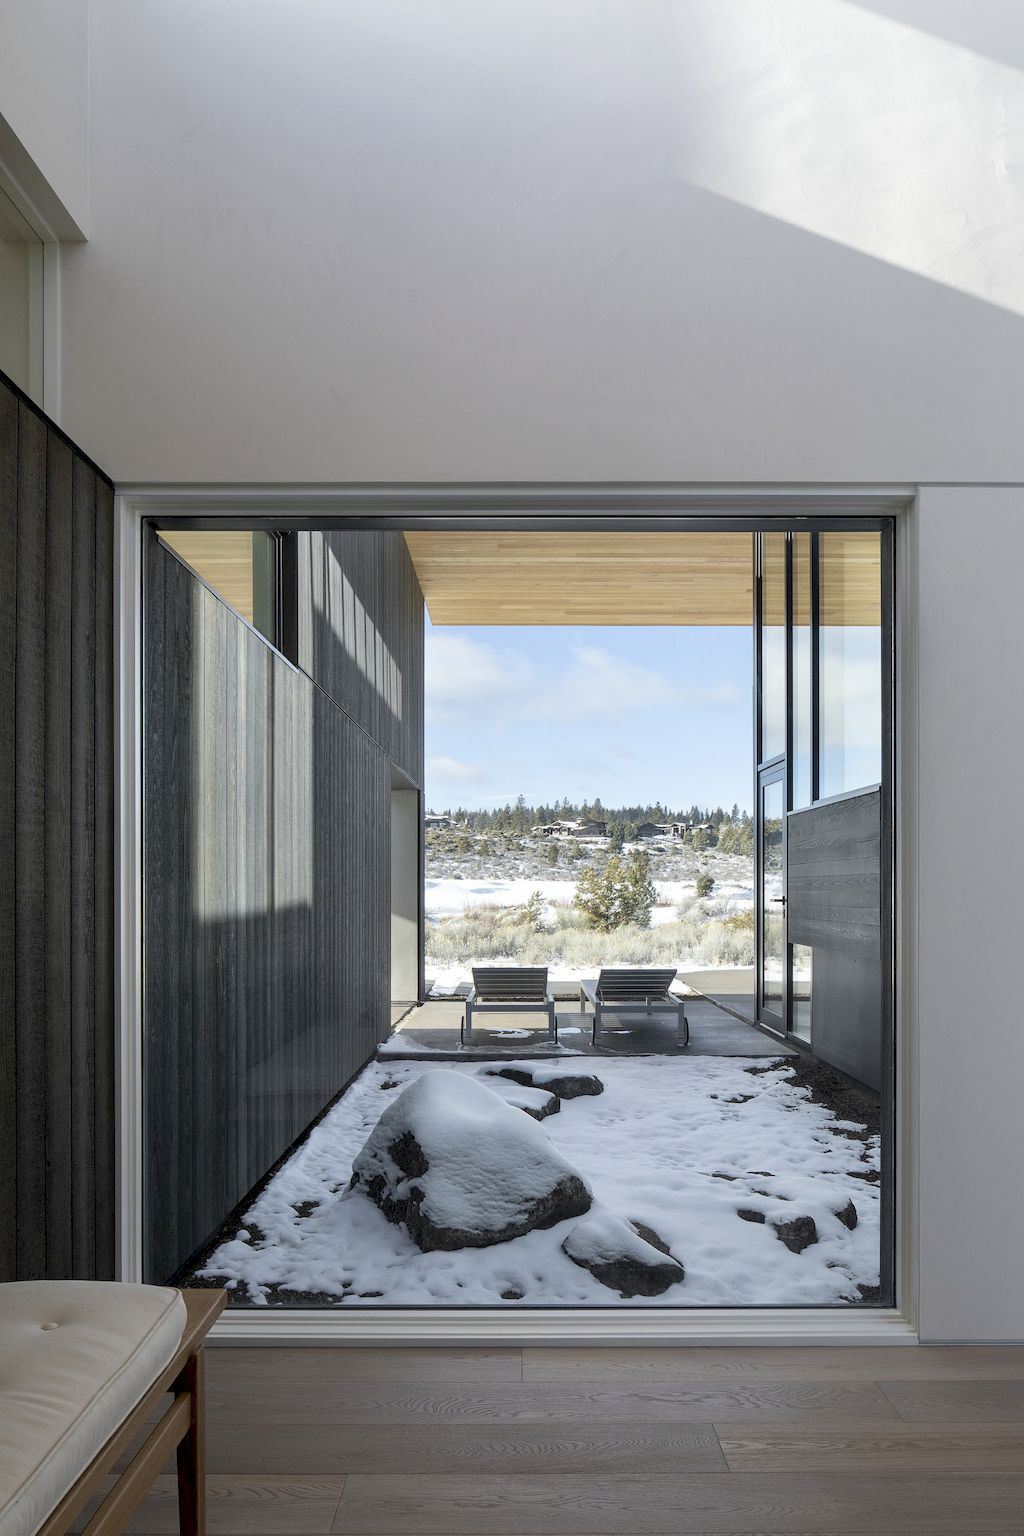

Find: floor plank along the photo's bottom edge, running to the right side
[333,1473,1024,1536]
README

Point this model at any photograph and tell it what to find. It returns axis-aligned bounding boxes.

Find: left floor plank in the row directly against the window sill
[206,1346,521,1393]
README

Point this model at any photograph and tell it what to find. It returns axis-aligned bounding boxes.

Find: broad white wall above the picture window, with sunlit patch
[66,0,1024,481]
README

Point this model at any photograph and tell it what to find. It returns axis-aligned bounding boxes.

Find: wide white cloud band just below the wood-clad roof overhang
[425,634,742,725]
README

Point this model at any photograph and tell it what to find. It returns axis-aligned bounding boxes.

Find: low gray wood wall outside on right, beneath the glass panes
[786,790,884,1089]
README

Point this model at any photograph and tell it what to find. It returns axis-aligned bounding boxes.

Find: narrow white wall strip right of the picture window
[910,487,1024,1342]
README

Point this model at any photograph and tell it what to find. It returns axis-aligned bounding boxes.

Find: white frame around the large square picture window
[115,484,918,1346]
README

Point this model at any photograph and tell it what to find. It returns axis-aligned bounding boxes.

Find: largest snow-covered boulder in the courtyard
[350,1072,591,1253]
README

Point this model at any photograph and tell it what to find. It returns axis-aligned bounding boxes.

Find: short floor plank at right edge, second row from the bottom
[718,1422,1024,1474]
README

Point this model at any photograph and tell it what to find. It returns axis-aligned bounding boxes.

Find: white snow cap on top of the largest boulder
[348,1072,589,1233]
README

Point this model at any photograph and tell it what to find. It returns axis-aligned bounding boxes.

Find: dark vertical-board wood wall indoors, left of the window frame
[0,378,114,1279]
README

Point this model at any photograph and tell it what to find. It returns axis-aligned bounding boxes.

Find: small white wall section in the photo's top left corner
[0,0,89,238]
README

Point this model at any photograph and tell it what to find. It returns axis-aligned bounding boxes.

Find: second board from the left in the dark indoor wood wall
[14,404,46,1279]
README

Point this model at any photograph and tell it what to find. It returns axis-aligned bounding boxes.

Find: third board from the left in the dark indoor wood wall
[43,433,74,1278]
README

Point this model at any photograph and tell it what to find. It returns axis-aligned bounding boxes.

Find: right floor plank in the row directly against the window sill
[524,1346,1024,1382]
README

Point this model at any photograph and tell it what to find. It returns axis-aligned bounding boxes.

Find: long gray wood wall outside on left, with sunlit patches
[143,533,422,1281]
